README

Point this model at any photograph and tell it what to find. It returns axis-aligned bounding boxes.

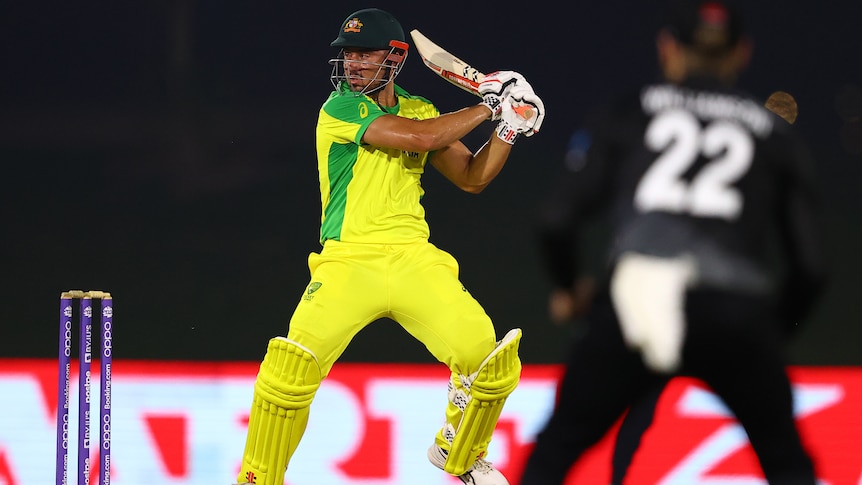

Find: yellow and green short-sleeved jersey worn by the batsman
[317,84,440,244]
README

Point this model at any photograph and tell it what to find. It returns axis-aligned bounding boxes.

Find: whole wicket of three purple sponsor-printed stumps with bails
[56,290,113,485]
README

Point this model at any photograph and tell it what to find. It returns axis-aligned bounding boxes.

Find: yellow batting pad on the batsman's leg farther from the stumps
[444,328,521,475]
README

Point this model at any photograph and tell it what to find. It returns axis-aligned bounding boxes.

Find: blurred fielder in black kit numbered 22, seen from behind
[520,1,825,485]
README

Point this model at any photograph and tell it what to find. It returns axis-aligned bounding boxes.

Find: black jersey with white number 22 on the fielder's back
[539,76,824,322]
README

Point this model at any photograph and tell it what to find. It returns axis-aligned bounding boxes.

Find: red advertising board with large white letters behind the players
[0,359,862,485]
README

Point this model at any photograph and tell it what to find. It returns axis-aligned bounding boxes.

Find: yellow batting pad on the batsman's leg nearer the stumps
[238,337,321,485]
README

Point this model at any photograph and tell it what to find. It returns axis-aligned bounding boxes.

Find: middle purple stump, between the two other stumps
[78,294,93,485]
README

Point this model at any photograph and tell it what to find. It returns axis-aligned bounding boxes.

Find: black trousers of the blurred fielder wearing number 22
[520,290,816,485]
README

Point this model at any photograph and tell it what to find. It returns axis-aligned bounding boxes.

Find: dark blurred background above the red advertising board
[0,0,862,365]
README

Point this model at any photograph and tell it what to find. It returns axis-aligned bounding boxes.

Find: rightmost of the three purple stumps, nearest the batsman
[99,295,114,485]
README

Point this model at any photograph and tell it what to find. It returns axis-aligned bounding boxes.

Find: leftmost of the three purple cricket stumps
[55,293,72,485]
